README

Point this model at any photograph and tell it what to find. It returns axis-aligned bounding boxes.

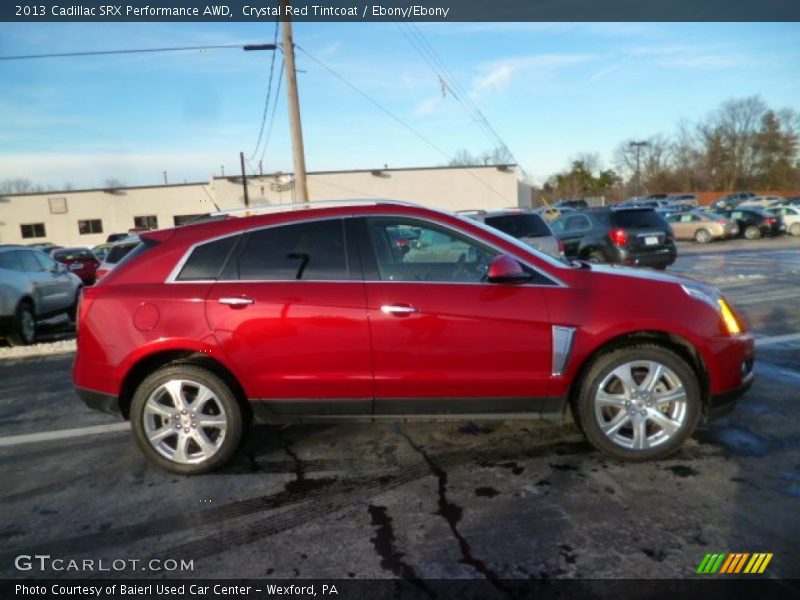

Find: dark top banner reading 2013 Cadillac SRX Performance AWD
[0,0,800,23]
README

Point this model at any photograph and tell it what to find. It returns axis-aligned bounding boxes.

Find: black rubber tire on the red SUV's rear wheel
[131,364,244,475]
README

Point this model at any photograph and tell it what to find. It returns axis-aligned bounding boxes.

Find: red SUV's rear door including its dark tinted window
[206,218,372,415]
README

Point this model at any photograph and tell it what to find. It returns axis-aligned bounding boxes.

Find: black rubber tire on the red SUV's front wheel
[573,344,702,462]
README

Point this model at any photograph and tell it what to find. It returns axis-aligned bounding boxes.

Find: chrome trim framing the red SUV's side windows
[164,212,569,288]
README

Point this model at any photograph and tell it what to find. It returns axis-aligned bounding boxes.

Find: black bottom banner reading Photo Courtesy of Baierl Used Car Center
[0,576,800,600]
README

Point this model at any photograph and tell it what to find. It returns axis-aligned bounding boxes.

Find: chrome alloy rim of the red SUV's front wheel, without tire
[594,360,688,450]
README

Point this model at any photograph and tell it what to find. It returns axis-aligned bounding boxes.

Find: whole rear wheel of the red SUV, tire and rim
[131,365,243,475]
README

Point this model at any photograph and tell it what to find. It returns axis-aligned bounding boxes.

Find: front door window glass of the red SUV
[367,218,498,283]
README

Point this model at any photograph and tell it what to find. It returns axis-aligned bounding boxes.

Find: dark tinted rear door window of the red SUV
[226,219,349,281]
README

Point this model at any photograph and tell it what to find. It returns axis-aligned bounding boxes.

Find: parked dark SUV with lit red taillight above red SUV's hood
[550,207,678,269]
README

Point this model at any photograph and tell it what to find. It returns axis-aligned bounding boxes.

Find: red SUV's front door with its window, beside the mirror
[360,216,552,415]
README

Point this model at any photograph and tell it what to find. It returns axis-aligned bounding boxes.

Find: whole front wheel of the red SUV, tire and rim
[576,345,701,461]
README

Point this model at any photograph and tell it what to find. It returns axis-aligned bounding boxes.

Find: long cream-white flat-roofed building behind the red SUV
[0,165,531,247]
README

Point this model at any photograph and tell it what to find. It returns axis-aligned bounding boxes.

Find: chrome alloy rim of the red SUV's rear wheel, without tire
[142,379,228,465]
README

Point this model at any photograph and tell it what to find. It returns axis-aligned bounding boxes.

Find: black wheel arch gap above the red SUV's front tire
[567,330,711,415]
